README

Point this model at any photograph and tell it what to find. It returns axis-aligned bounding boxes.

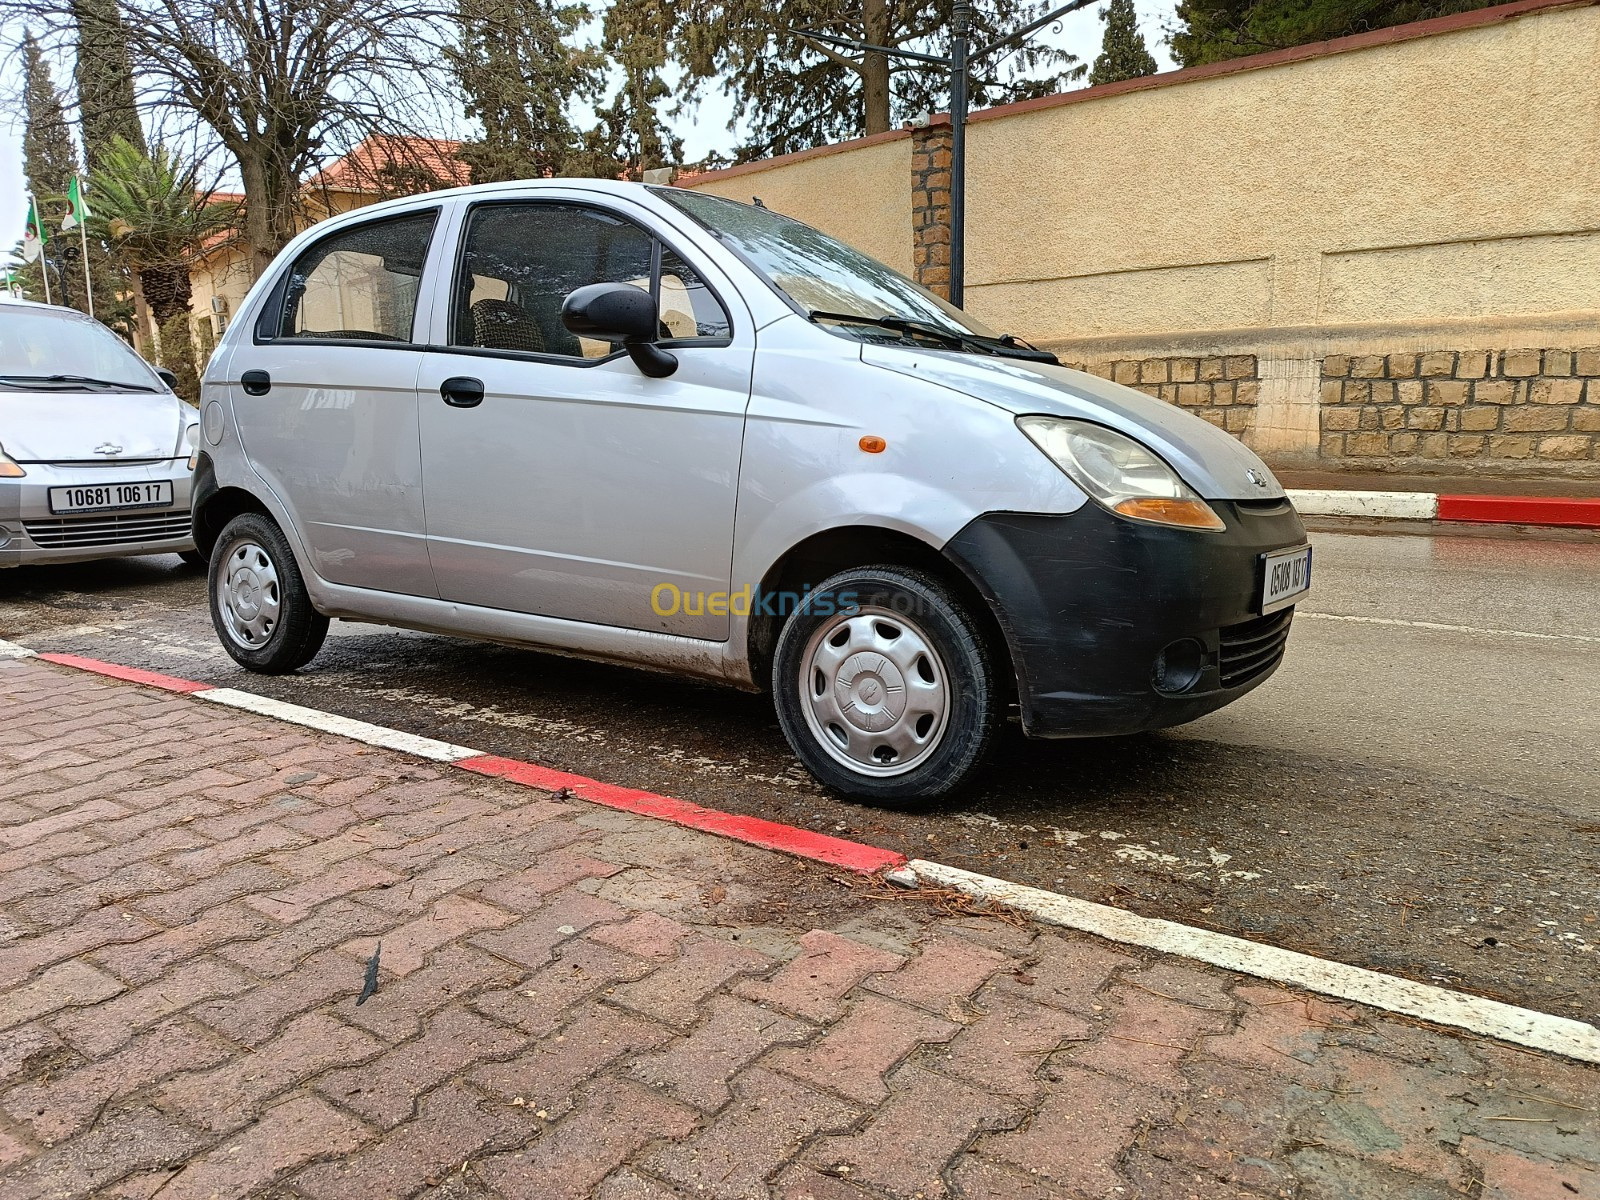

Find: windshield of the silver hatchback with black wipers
[653,187,994,341]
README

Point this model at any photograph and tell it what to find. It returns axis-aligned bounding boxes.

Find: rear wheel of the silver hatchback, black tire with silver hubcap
[206,512,328,675]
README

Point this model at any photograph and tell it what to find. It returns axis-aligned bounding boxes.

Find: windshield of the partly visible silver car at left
[0,304,165,392]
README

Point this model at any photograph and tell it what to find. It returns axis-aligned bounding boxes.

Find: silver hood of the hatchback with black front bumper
[861,346,1283,501]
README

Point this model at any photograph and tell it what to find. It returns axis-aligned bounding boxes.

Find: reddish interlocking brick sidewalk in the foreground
[0,661,1600,1200]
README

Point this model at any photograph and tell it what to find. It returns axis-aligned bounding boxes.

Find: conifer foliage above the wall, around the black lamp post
[675,0,1083,160]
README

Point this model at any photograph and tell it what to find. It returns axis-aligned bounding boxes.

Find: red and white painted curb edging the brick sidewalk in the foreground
[0,640,1600,1062]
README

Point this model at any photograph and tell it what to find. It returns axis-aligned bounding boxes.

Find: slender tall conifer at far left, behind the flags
[21,34,86,307]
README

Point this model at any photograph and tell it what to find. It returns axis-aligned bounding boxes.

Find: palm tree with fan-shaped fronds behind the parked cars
[90,138,238,400]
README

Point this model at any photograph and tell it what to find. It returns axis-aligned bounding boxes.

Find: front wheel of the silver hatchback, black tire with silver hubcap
[773,566,1003,808]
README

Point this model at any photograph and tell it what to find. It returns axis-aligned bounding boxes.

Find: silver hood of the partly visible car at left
[0,390,198,462]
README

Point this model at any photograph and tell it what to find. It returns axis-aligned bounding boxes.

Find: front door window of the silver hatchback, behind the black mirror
[451,205,730,358]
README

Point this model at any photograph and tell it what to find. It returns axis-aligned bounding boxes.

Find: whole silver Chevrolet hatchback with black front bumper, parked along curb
[194,179,1310,803]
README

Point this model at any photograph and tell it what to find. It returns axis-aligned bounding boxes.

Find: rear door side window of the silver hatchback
[274,210,437,342]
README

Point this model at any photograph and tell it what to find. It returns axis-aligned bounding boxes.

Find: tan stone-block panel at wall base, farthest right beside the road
[1322,347,1600,467]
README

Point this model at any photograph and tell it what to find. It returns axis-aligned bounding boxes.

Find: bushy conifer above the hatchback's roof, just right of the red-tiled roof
[450,0,605,184]
